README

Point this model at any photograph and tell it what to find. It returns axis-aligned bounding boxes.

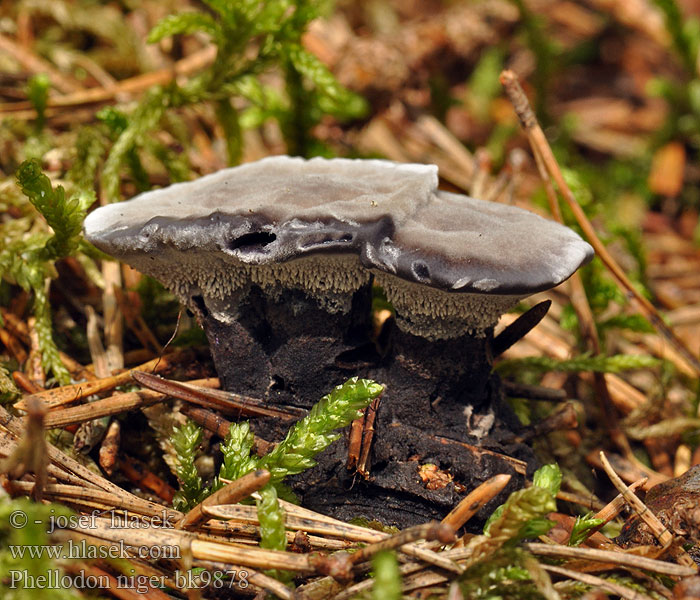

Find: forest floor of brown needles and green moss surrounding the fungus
[0,0,700,600]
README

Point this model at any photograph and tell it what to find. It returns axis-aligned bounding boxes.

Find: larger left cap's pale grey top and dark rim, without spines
[85,156,437,264]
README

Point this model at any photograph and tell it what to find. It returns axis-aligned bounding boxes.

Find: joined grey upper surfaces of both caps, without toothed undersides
[84,156,593,295]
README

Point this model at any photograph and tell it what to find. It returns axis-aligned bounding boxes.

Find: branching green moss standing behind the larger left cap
[102,0,366,201]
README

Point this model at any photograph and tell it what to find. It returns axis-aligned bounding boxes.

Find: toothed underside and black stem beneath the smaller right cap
[364,273,520,439]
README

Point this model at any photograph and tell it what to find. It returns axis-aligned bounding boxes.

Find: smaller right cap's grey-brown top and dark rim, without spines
[373,191,593,295]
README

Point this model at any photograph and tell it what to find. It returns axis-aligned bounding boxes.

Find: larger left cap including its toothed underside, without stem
[84,156,437,320]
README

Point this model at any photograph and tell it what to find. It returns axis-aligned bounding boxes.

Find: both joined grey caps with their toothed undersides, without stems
[84,156,593,330]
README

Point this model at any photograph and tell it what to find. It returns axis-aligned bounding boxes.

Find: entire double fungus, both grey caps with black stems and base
[84,156,593,525]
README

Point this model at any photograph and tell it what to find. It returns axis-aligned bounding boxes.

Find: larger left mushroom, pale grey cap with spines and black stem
[84,156,437,406]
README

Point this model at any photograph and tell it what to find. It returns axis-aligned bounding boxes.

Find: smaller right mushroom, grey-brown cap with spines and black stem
[369,191,593,442]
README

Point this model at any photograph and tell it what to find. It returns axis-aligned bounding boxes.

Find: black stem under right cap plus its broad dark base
[290,319,535,527]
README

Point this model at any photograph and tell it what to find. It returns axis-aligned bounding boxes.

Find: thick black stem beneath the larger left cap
[198,283,373,408]
